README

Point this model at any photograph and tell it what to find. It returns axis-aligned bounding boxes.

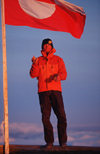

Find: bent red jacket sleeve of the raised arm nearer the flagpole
[30,59,39,78]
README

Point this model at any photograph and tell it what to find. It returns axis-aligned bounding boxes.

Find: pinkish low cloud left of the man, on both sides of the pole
[0,123,43,144]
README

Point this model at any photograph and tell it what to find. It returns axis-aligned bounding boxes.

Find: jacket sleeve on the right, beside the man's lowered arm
[58,58,67,80]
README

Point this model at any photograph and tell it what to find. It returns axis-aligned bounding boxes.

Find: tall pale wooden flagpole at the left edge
[1,0,9,154]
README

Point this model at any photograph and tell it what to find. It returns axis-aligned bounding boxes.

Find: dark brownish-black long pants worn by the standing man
[39,91,67,145]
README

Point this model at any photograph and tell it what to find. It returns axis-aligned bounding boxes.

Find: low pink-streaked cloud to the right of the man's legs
[68,128,100,146]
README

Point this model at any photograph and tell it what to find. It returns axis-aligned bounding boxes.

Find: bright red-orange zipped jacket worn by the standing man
[30,48,67,92]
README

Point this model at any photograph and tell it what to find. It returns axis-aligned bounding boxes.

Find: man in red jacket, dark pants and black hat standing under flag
[30,38,67,148]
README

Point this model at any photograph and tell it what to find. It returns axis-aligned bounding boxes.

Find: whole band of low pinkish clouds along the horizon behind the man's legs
[0,123,100,146]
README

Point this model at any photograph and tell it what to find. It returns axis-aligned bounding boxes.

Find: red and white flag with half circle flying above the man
[4,0,86,38]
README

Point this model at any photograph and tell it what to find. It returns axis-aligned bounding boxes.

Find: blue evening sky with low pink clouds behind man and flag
[0,0,100,146]
